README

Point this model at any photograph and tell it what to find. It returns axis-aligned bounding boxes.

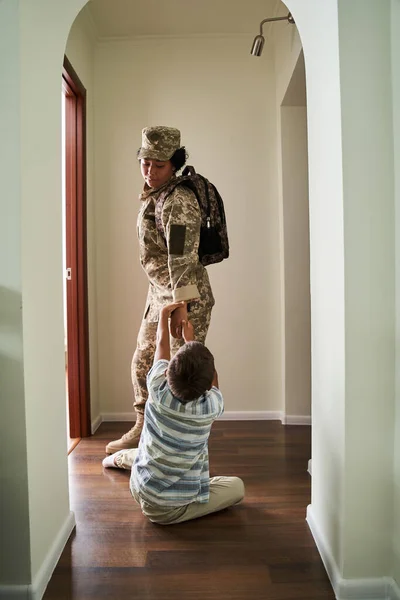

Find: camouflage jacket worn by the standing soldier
[137,177,214,321]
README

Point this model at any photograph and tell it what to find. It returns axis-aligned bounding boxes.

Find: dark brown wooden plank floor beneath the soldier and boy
[44,421,334,600]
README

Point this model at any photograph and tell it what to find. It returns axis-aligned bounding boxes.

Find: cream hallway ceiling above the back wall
[86,0,283,38]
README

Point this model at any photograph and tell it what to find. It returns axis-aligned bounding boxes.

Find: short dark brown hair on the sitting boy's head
[167,342,215,403]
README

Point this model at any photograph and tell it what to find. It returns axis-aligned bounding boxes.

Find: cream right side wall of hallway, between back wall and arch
[272,17,311,423]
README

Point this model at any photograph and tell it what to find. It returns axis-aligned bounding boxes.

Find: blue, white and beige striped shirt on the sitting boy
[131,360,224,507]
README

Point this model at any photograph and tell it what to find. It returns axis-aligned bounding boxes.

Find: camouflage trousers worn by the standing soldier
[131,302,212,413]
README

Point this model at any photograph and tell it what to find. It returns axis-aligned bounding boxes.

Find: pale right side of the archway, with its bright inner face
[277,0,394,589]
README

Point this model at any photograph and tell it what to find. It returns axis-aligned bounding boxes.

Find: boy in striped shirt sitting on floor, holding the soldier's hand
[103,303,244,524]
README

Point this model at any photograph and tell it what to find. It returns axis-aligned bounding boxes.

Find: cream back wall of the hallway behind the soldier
[95,36,282,413]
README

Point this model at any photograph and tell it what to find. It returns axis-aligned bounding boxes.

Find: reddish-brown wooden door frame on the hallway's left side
[62,56,91,438]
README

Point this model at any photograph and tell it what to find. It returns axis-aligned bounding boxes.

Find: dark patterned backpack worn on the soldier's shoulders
[155,166,229,266]
